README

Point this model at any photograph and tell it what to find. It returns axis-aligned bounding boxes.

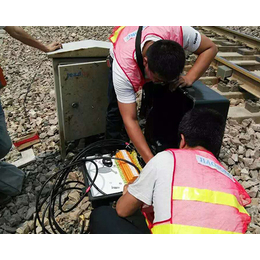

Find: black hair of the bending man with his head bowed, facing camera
[146,40,185,81]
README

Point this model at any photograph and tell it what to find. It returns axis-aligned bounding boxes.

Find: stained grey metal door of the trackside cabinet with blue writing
[58,60,108,141]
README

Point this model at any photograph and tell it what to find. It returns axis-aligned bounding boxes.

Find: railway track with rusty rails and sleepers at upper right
[185,26,260,123]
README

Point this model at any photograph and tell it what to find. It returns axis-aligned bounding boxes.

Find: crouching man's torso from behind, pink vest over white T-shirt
[128,149,250,233]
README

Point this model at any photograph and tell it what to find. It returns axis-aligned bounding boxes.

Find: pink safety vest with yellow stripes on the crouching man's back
[144,149,251,234]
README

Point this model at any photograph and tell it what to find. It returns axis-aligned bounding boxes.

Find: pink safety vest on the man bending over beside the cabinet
[109,26,183,92]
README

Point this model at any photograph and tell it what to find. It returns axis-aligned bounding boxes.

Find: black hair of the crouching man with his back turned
[178,108,225,158]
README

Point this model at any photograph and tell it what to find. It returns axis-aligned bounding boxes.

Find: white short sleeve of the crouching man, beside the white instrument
[128,156,157,205]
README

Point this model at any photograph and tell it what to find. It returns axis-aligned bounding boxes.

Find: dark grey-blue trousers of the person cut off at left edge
[0,98,25,196]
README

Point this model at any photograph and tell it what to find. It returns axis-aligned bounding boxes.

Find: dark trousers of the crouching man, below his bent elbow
[89,206,151,234]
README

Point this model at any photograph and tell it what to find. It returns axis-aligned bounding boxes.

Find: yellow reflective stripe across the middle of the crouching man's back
[172,186,249,215]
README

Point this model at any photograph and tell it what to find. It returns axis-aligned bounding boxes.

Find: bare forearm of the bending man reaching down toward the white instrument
[118,101,153,163]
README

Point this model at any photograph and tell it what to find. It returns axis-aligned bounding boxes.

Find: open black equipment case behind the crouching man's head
[139,81,230,154]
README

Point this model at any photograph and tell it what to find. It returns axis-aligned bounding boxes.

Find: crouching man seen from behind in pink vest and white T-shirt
[90,109,251,234]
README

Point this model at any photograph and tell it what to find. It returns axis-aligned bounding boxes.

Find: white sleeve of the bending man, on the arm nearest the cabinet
[112,59,136,103]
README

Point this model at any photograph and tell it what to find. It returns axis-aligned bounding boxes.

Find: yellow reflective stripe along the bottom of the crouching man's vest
[151,224,242,234]
